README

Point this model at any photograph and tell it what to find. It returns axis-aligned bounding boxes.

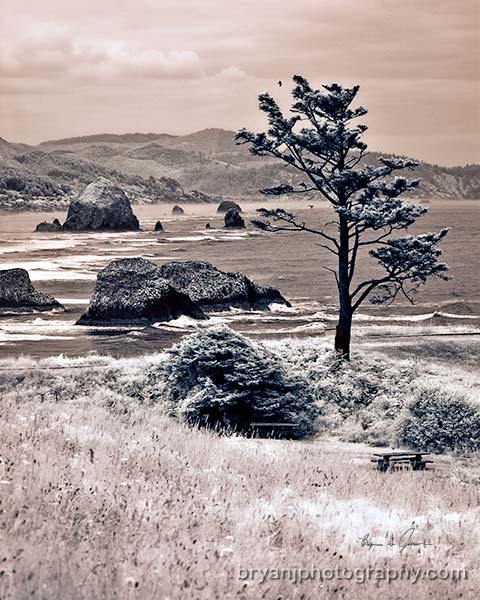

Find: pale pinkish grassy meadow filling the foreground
[0,352,480,600]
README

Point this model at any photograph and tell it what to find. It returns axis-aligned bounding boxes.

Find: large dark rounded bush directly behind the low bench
[154,326,317,438]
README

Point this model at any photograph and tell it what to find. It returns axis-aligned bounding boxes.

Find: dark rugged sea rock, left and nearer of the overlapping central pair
[77,258,206,325]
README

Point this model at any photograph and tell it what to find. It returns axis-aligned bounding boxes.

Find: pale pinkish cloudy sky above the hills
[0,0,480,165]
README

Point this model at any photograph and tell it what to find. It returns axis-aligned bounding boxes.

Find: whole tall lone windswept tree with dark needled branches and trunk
[235,75,448,360]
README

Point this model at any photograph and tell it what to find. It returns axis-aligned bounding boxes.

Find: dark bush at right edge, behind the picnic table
[398,388,480,452]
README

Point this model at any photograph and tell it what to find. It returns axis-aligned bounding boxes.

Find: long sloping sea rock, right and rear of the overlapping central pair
[160,261,290,311]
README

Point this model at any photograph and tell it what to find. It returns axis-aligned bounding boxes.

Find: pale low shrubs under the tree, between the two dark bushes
[268,339,420,445]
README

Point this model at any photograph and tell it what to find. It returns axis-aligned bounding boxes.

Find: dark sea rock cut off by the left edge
[0,269,64,312]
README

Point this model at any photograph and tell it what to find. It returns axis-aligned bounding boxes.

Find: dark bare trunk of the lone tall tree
[335,216,352,360]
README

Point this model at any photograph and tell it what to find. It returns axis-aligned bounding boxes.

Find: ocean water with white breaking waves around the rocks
[0,200,480,363]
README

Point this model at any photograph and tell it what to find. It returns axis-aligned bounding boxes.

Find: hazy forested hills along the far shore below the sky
[0,129,480,210]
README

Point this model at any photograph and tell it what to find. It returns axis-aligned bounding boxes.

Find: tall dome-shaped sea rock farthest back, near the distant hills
[63,177,140,231]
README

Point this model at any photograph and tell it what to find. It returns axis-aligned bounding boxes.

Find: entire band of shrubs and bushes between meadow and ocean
[0,326,480,452]
